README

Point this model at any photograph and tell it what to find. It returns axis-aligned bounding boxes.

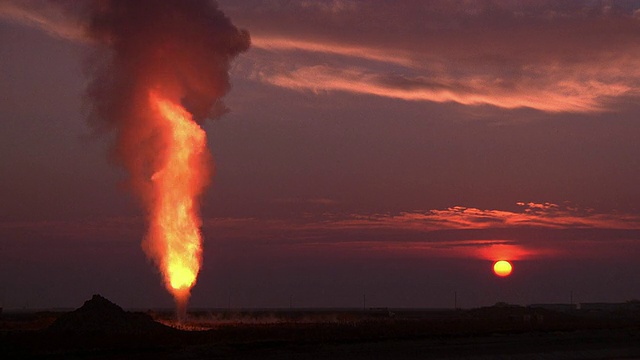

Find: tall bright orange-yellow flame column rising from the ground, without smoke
[145,93,210,315]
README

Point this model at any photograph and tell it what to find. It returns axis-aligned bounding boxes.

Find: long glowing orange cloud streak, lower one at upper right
[258,65,632,112]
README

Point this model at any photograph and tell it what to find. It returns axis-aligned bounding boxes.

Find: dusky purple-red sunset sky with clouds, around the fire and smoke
[0,0,640,308]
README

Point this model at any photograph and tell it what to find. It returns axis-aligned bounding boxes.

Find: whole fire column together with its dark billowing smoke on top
[77,0,250,311]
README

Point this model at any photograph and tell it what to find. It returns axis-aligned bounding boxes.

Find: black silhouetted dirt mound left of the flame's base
[48,295,172,334]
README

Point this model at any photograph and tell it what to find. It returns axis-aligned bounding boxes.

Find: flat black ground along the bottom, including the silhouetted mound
[0,296,640,360]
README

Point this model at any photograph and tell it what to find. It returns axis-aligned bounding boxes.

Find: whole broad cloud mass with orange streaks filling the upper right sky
[228,1,640,112]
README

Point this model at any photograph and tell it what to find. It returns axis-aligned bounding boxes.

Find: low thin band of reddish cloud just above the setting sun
[5,199,640,260]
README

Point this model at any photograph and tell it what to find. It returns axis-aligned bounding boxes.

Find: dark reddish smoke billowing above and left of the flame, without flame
[74,0,250,197]
